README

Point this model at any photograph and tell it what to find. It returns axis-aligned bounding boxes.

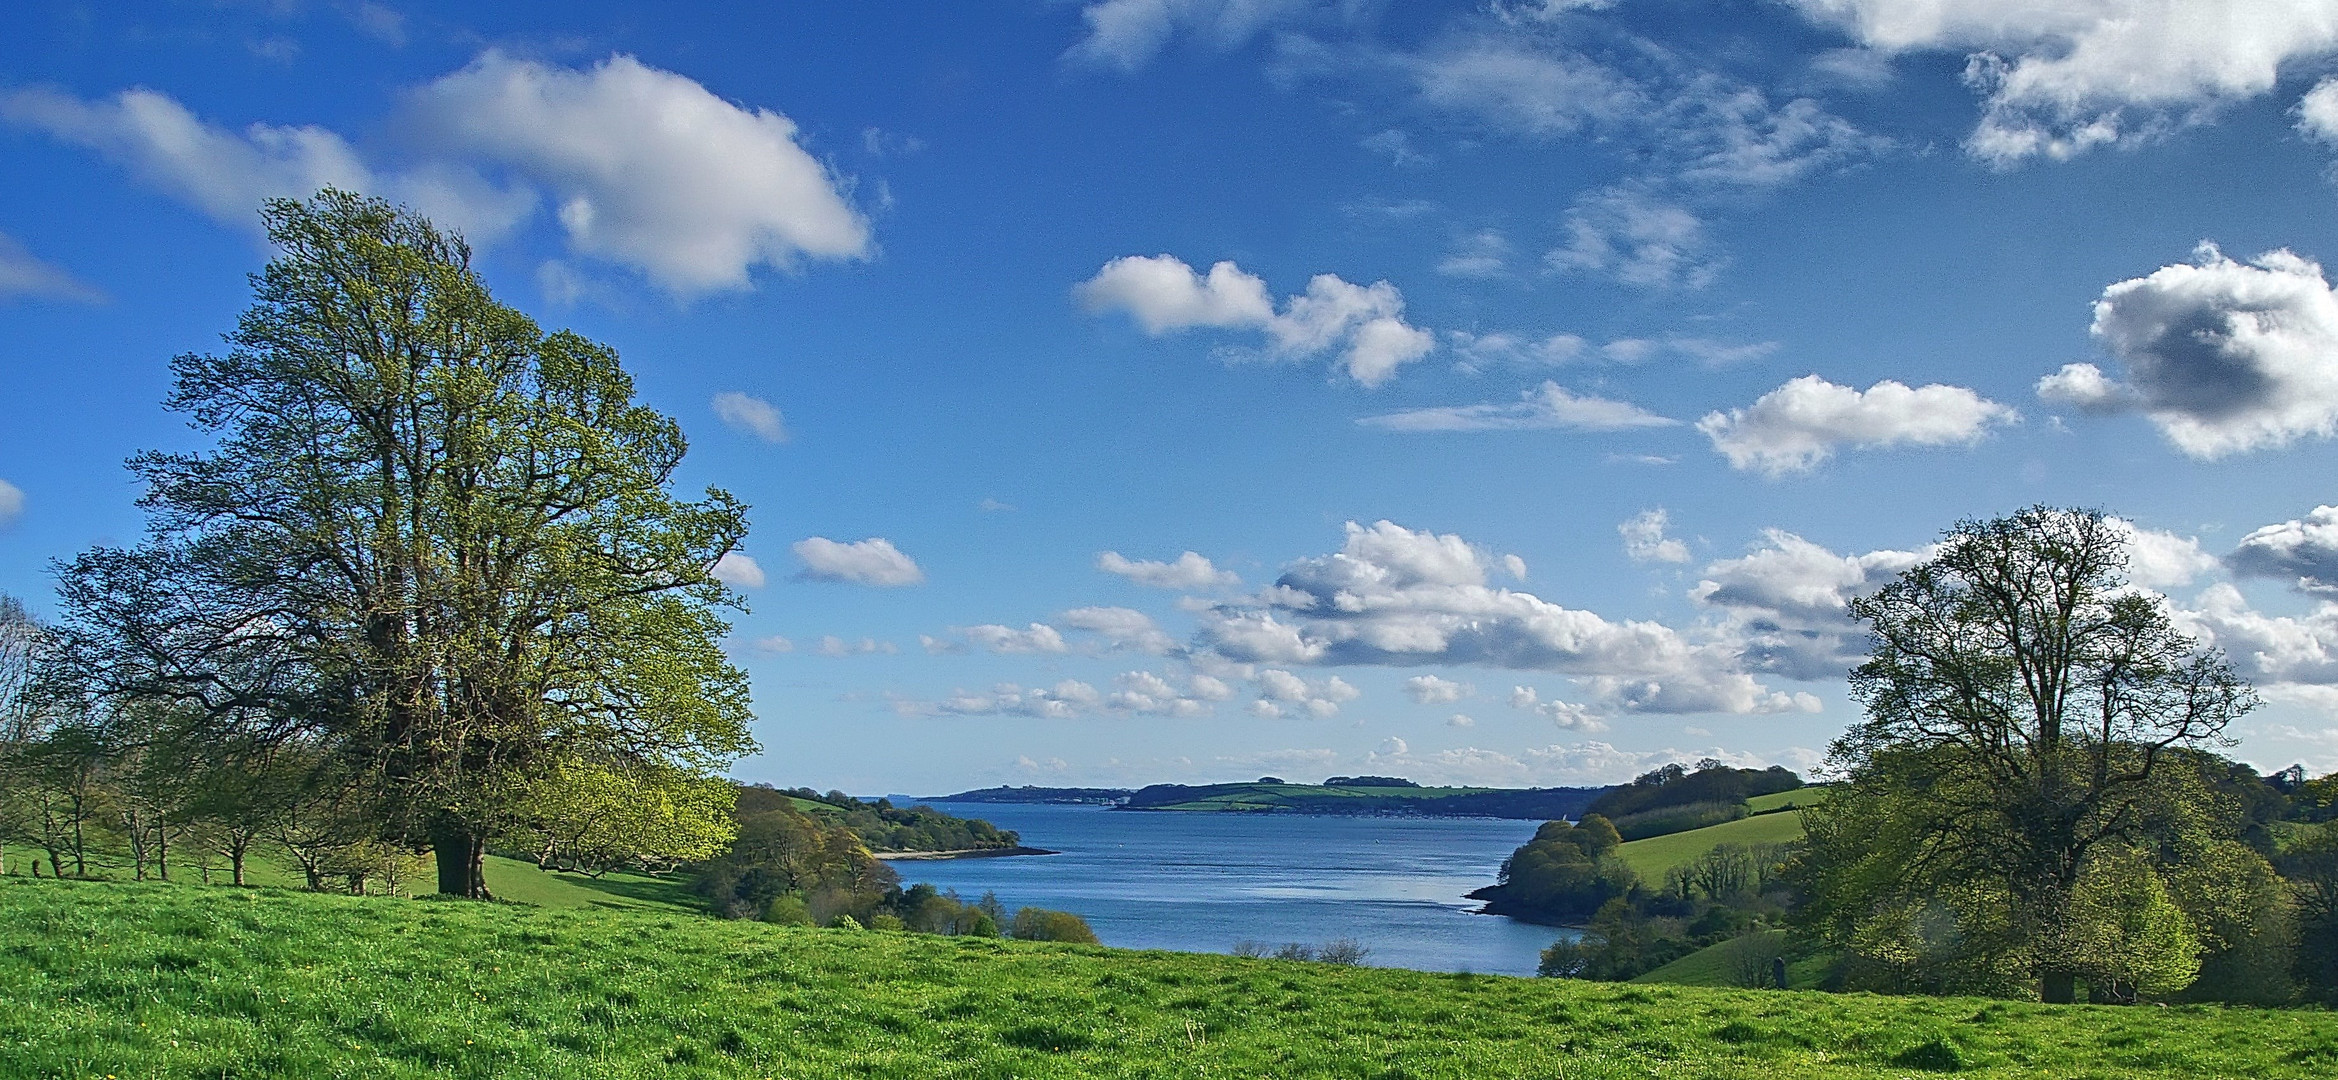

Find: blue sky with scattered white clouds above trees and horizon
[0,0,2338,792]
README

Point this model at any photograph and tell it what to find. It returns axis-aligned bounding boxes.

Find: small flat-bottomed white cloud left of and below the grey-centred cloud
[1697,374,2020,477]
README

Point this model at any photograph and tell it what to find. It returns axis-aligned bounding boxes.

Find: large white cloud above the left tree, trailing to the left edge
[0,49,872,295]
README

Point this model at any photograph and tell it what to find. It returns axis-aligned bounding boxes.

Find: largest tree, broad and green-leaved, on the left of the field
[61,189,753,895]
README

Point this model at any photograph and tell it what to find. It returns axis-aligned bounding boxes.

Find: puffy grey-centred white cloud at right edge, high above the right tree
[2036,243,2338,461]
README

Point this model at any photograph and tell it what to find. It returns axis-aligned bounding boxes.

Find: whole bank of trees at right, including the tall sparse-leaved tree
[1503,507,2338,1003]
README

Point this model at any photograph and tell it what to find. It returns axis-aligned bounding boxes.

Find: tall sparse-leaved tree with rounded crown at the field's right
[1796,507,2270,1001]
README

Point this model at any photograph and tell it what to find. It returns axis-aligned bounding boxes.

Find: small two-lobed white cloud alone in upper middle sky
[1073,255,1436,386]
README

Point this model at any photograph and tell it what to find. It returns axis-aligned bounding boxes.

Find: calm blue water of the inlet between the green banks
[893,802,1571,975]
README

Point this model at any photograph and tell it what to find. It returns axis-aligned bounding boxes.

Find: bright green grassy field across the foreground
[0,877,2338,1080]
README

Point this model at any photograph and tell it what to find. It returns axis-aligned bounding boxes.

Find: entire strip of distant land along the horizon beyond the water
[931,776,1609,821]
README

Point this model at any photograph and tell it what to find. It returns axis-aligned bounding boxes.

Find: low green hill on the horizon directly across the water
[1120,776,1606,821]
